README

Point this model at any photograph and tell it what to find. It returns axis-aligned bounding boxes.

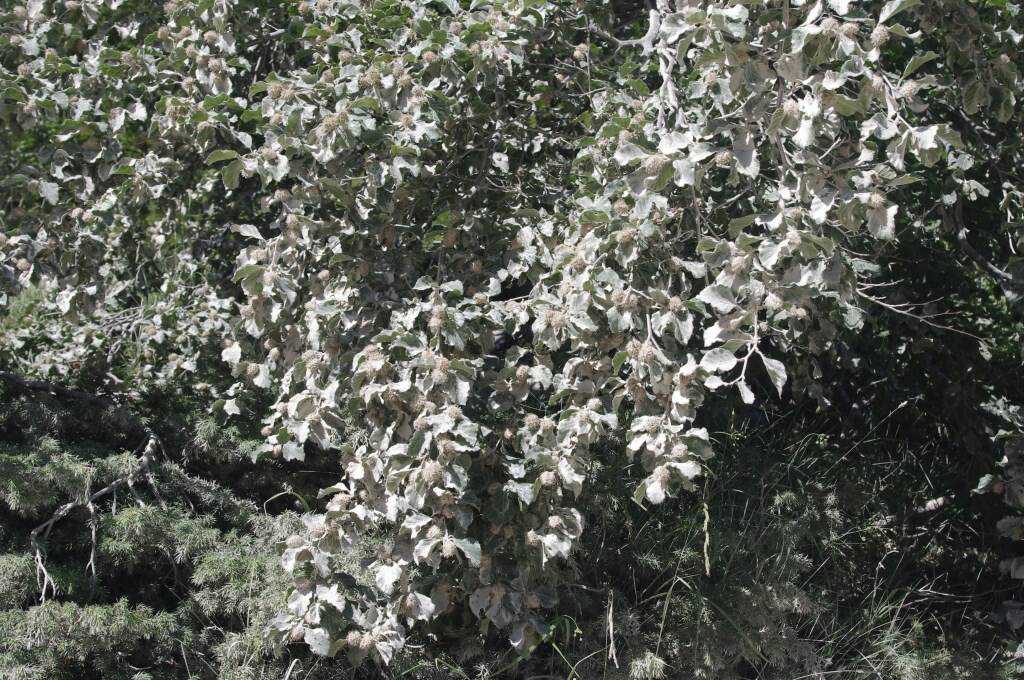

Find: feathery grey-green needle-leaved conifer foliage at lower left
[0,390,362,680]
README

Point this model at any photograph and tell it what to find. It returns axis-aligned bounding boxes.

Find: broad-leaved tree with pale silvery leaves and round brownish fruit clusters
[0,0,1024,677]
